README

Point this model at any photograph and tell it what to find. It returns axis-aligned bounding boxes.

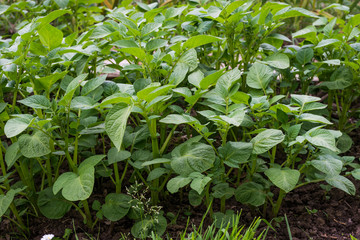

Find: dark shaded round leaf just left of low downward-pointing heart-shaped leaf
[234,182,266,207]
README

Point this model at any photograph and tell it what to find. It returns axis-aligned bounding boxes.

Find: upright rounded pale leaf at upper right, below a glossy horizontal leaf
[246,63,273,92]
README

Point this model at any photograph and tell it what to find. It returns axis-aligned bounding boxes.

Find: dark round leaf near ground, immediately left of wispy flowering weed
[102,193,132,222]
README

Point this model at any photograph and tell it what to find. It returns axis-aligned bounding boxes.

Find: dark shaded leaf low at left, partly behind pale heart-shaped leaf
[37,187,72,219]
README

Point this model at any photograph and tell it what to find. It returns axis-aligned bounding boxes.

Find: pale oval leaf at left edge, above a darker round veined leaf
[4,114,34,138]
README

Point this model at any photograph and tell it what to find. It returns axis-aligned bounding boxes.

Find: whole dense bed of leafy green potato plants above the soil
[0,0,360,237]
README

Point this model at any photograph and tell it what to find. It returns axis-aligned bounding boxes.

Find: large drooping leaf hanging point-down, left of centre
[105,103,133,151]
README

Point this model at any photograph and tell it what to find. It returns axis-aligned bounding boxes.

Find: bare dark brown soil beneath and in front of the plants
[0,130,360,240]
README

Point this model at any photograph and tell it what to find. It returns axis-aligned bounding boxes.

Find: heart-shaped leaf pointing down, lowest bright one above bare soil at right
[265,168,300,193]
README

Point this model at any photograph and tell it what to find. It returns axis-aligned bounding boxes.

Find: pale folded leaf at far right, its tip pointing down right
[305,129,339,152]
